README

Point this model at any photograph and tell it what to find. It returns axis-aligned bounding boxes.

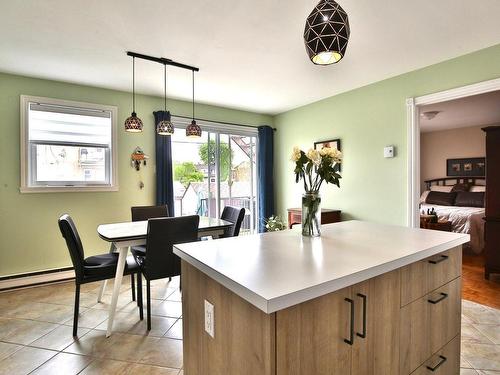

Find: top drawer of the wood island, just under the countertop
[401,246,462,306]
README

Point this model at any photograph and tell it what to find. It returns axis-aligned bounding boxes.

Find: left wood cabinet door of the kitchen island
[276,288,354,375]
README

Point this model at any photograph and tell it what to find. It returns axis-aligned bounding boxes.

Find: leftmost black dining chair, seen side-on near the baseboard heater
[58,214,140,336]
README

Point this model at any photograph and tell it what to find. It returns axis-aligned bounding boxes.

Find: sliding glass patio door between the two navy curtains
[172,116,258,235]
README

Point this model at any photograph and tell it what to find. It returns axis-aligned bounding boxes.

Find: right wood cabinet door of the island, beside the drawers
[352,270,400,375]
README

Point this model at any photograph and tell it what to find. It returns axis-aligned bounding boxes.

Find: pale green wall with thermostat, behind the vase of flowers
[274,44,500,225]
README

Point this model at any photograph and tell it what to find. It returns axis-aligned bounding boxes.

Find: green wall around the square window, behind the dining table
[0,73,272,277]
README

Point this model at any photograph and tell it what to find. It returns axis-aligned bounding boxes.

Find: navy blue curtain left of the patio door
[153,111,174,216]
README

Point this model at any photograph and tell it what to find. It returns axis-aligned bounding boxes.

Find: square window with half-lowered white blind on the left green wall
[21,95,118,192]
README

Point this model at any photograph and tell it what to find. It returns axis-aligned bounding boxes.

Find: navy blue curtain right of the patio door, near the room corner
[257,126,275,233]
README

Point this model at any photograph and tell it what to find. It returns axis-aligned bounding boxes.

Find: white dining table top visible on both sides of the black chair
[97,216,233,242]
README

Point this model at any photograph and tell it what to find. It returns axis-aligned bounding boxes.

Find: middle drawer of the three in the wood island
[400,277,461,374]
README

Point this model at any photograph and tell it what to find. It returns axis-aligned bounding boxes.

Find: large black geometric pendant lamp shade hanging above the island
[304,0,350,65]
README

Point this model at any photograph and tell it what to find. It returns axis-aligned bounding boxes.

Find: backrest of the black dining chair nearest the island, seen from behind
[144,215,200,280]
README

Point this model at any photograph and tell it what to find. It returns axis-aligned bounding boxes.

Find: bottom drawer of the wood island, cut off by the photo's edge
[411,335,460,375]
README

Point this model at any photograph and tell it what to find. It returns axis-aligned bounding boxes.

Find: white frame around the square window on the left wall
[19,95,119,193]
